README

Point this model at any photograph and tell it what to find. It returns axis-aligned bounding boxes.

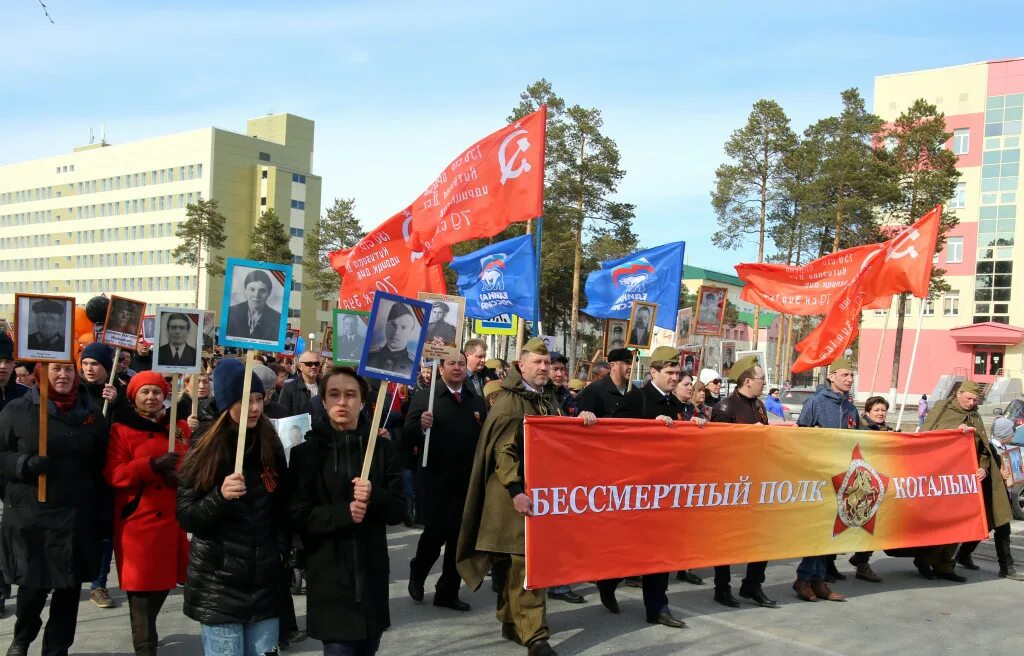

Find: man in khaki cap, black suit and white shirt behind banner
[595,346,686,628]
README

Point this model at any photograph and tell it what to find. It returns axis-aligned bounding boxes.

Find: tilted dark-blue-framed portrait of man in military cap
[358,292,430,385]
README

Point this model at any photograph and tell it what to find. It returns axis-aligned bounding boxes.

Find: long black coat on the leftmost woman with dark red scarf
[0,383,110,588]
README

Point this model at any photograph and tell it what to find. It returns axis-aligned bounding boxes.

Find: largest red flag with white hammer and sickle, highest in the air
[408,105,548,264]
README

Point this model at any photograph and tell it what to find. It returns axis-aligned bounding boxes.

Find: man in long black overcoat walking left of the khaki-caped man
[402,353,487,611]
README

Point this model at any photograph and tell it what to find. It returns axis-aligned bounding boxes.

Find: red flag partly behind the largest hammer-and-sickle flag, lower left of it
[330,210,452,311]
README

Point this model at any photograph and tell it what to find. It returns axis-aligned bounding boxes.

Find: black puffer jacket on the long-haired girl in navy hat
[177,420,290,624]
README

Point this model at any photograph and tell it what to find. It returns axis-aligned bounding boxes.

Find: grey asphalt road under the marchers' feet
[0,522,1024,656]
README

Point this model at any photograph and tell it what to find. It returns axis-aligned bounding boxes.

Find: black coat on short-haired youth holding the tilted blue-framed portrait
[289,422,406,641]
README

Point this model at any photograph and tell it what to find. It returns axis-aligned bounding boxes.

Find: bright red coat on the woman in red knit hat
[103,412,188,592]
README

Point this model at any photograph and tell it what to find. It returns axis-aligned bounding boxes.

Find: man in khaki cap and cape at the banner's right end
[914,381,1024,582]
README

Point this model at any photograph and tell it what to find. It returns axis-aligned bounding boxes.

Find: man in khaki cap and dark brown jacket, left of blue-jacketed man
[700,355,778,608]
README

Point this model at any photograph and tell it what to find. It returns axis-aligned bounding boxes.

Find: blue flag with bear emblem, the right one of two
[583,242,686,331]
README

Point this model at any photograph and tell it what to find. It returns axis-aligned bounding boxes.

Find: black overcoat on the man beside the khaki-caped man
[402,381,487,527]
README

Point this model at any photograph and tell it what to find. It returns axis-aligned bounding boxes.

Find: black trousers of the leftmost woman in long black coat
[11,585,82,656]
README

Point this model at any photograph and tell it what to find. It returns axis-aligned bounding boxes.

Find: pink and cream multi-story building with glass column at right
[857,58,1024,401]
